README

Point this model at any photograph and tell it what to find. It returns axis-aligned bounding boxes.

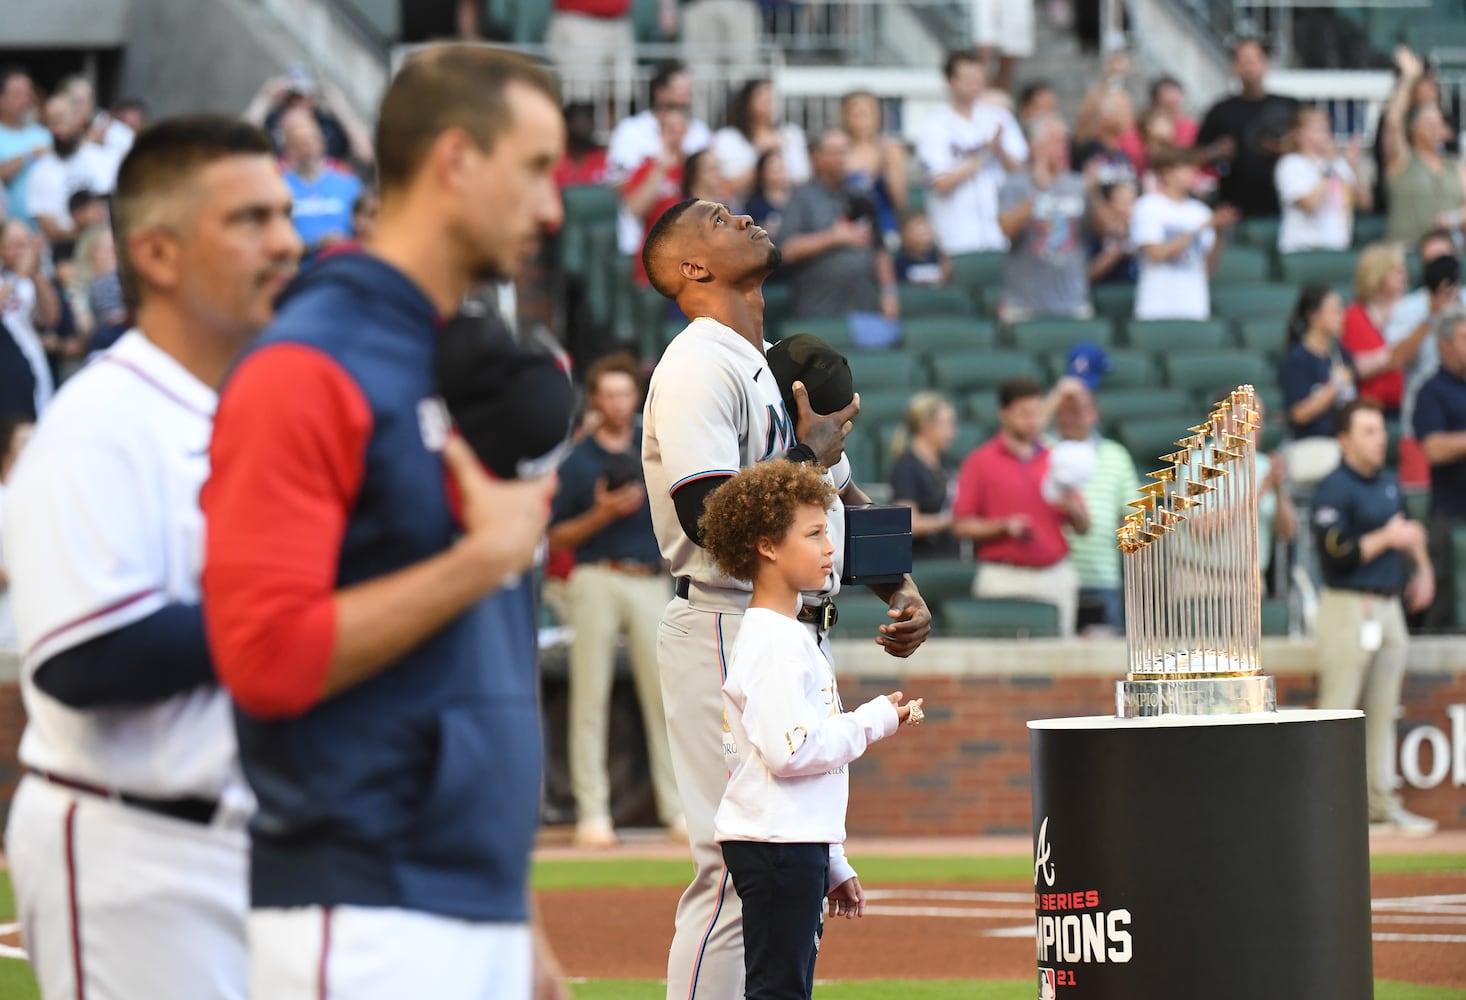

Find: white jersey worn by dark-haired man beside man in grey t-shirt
[916,101,1028,254]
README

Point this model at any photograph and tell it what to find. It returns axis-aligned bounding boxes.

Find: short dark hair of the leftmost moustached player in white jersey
[111,114,274,308]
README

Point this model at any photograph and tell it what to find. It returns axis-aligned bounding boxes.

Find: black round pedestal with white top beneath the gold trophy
[1028,711,1374,1000]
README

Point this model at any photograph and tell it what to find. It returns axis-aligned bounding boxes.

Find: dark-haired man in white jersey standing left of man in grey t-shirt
[916,51,1028,257]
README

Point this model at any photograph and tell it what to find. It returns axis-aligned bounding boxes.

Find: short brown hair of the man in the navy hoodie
[377,45,560,192]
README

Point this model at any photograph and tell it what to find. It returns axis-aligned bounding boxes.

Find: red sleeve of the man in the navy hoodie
[199,345,372,718]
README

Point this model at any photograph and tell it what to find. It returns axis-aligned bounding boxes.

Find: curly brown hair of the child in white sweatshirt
[698,459,836,581]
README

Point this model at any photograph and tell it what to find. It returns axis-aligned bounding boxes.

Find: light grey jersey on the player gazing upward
[642,317,850,597]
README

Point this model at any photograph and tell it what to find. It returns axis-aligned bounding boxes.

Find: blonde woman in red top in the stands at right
[1340,243,1409,416]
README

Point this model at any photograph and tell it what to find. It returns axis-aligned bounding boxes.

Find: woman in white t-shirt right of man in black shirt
[1272,107,1374,254]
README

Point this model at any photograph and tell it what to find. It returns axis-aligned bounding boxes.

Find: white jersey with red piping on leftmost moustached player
[4,330,248,799]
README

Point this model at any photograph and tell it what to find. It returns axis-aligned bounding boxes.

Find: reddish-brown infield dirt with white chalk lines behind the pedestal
[538,872,1466,988]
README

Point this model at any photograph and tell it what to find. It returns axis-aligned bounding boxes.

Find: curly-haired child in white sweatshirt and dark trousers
[699,459,922,997]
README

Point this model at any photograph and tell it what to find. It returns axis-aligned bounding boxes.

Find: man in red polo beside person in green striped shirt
[951,378,1089,638]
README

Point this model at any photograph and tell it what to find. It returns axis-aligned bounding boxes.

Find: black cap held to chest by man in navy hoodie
[437,302,575,479]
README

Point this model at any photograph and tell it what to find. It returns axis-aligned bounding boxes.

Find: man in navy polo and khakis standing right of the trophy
[1314,399,1435,836]
